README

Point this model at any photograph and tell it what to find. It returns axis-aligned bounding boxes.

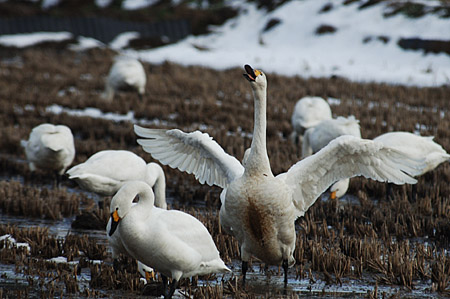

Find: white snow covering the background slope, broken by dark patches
[0,0,450,86]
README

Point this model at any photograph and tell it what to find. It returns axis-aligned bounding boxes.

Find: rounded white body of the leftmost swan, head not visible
[21,124,75,175]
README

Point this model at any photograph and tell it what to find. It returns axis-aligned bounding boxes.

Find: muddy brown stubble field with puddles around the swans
[0,44,450,298]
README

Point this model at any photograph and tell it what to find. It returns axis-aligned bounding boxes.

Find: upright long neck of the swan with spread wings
[245,86,273,176]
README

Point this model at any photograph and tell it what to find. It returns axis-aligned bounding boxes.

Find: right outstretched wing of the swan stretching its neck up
[278,135,425,216]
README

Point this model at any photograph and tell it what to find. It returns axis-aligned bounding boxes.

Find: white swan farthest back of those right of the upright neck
[290,97,331,144]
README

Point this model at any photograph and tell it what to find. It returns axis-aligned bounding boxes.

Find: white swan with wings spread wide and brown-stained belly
[134,65,423,285]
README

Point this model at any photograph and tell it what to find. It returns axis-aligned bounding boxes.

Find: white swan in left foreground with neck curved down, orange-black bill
[108,181,230,298]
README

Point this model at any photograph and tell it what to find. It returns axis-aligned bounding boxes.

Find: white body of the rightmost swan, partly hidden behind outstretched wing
[374,132,450,175]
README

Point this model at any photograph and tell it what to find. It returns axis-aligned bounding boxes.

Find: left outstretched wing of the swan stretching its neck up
[134,125,244,188]
